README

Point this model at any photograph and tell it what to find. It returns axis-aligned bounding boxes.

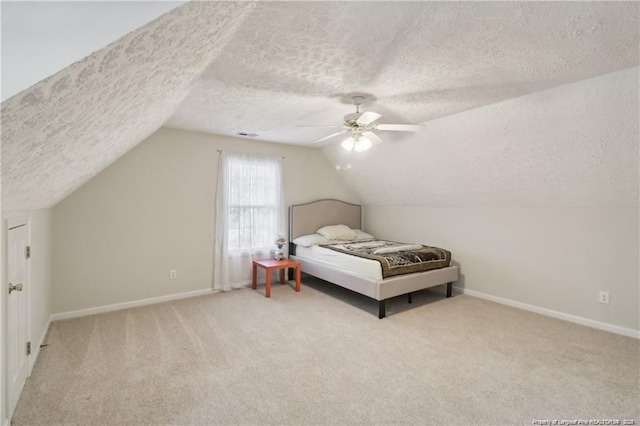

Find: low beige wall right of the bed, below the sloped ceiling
[364,206,640,330]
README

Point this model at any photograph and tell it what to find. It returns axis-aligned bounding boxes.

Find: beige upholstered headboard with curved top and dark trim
[289,199,362,241]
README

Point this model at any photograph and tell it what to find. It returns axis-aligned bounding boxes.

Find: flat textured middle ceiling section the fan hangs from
[167,2,638,143]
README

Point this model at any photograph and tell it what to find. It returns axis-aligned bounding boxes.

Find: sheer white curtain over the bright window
[213,152,286,291]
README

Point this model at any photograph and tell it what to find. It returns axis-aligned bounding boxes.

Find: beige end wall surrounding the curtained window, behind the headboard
[53,128,359,313]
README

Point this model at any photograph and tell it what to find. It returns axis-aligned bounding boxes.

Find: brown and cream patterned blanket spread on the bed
[321,240,451,278]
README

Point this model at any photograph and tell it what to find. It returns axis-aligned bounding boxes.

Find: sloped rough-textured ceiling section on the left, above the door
[2,2,255,210]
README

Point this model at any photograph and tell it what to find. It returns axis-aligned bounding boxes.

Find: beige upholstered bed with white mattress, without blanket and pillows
[289,200,459,318]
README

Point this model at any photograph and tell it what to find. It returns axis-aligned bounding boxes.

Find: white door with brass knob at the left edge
[3,225,29,418]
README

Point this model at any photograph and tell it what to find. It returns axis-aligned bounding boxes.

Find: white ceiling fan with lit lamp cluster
[298,96,424,152]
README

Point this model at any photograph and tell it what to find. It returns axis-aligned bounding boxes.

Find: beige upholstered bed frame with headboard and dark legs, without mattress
[289,199,459,319]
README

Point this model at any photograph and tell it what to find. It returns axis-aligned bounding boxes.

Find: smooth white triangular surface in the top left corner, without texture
[0,1,185,101]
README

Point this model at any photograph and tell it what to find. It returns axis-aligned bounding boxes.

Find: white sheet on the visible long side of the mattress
[296,246,382,280]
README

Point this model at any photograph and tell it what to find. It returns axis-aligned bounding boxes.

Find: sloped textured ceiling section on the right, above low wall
[323,67,640,209]
